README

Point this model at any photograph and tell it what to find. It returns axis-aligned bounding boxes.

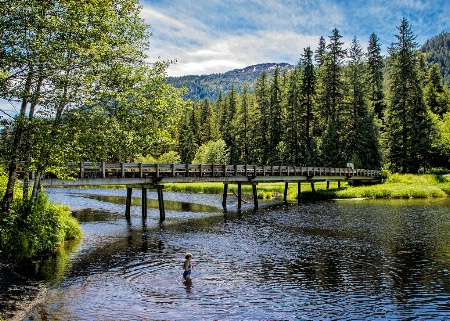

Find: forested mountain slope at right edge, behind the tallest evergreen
[420,32,450,86]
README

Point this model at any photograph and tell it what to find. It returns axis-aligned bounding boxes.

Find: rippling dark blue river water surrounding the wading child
[23,189,450,320]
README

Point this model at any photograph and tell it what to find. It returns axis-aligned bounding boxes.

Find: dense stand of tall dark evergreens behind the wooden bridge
[170,19,450,173]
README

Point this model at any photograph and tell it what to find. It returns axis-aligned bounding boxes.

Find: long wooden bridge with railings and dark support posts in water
[41,162,382,221]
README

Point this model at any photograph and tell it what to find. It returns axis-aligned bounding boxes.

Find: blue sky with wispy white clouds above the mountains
[141,0,450,76]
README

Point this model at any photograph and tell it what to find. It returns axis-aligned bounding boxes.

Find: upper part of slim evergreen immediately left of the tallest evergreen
[367,33,385,119]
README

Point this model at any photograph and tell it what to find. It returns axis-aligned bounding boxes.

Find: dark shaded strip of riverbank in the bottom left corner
[0,257,47,321]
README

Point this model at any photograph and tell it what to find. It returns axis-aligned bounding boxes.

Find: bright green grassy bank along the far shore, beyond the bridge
[164,174,450,200]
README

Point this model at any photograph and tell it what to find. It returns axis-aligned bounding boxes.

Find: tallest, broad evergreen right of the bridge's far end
[385,19,431,173]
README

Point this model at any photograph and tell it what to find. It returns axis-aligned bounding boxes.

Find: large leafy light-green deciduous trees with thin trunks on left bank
[0,0,184,212]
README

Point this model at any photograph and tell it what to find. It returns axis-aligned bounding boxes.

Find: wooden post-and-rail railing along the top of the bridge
[58,162,381,179]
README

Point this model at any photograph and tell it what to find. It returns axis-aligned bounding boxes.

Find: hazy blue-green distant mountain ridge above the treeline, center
[167,63,294,101]
